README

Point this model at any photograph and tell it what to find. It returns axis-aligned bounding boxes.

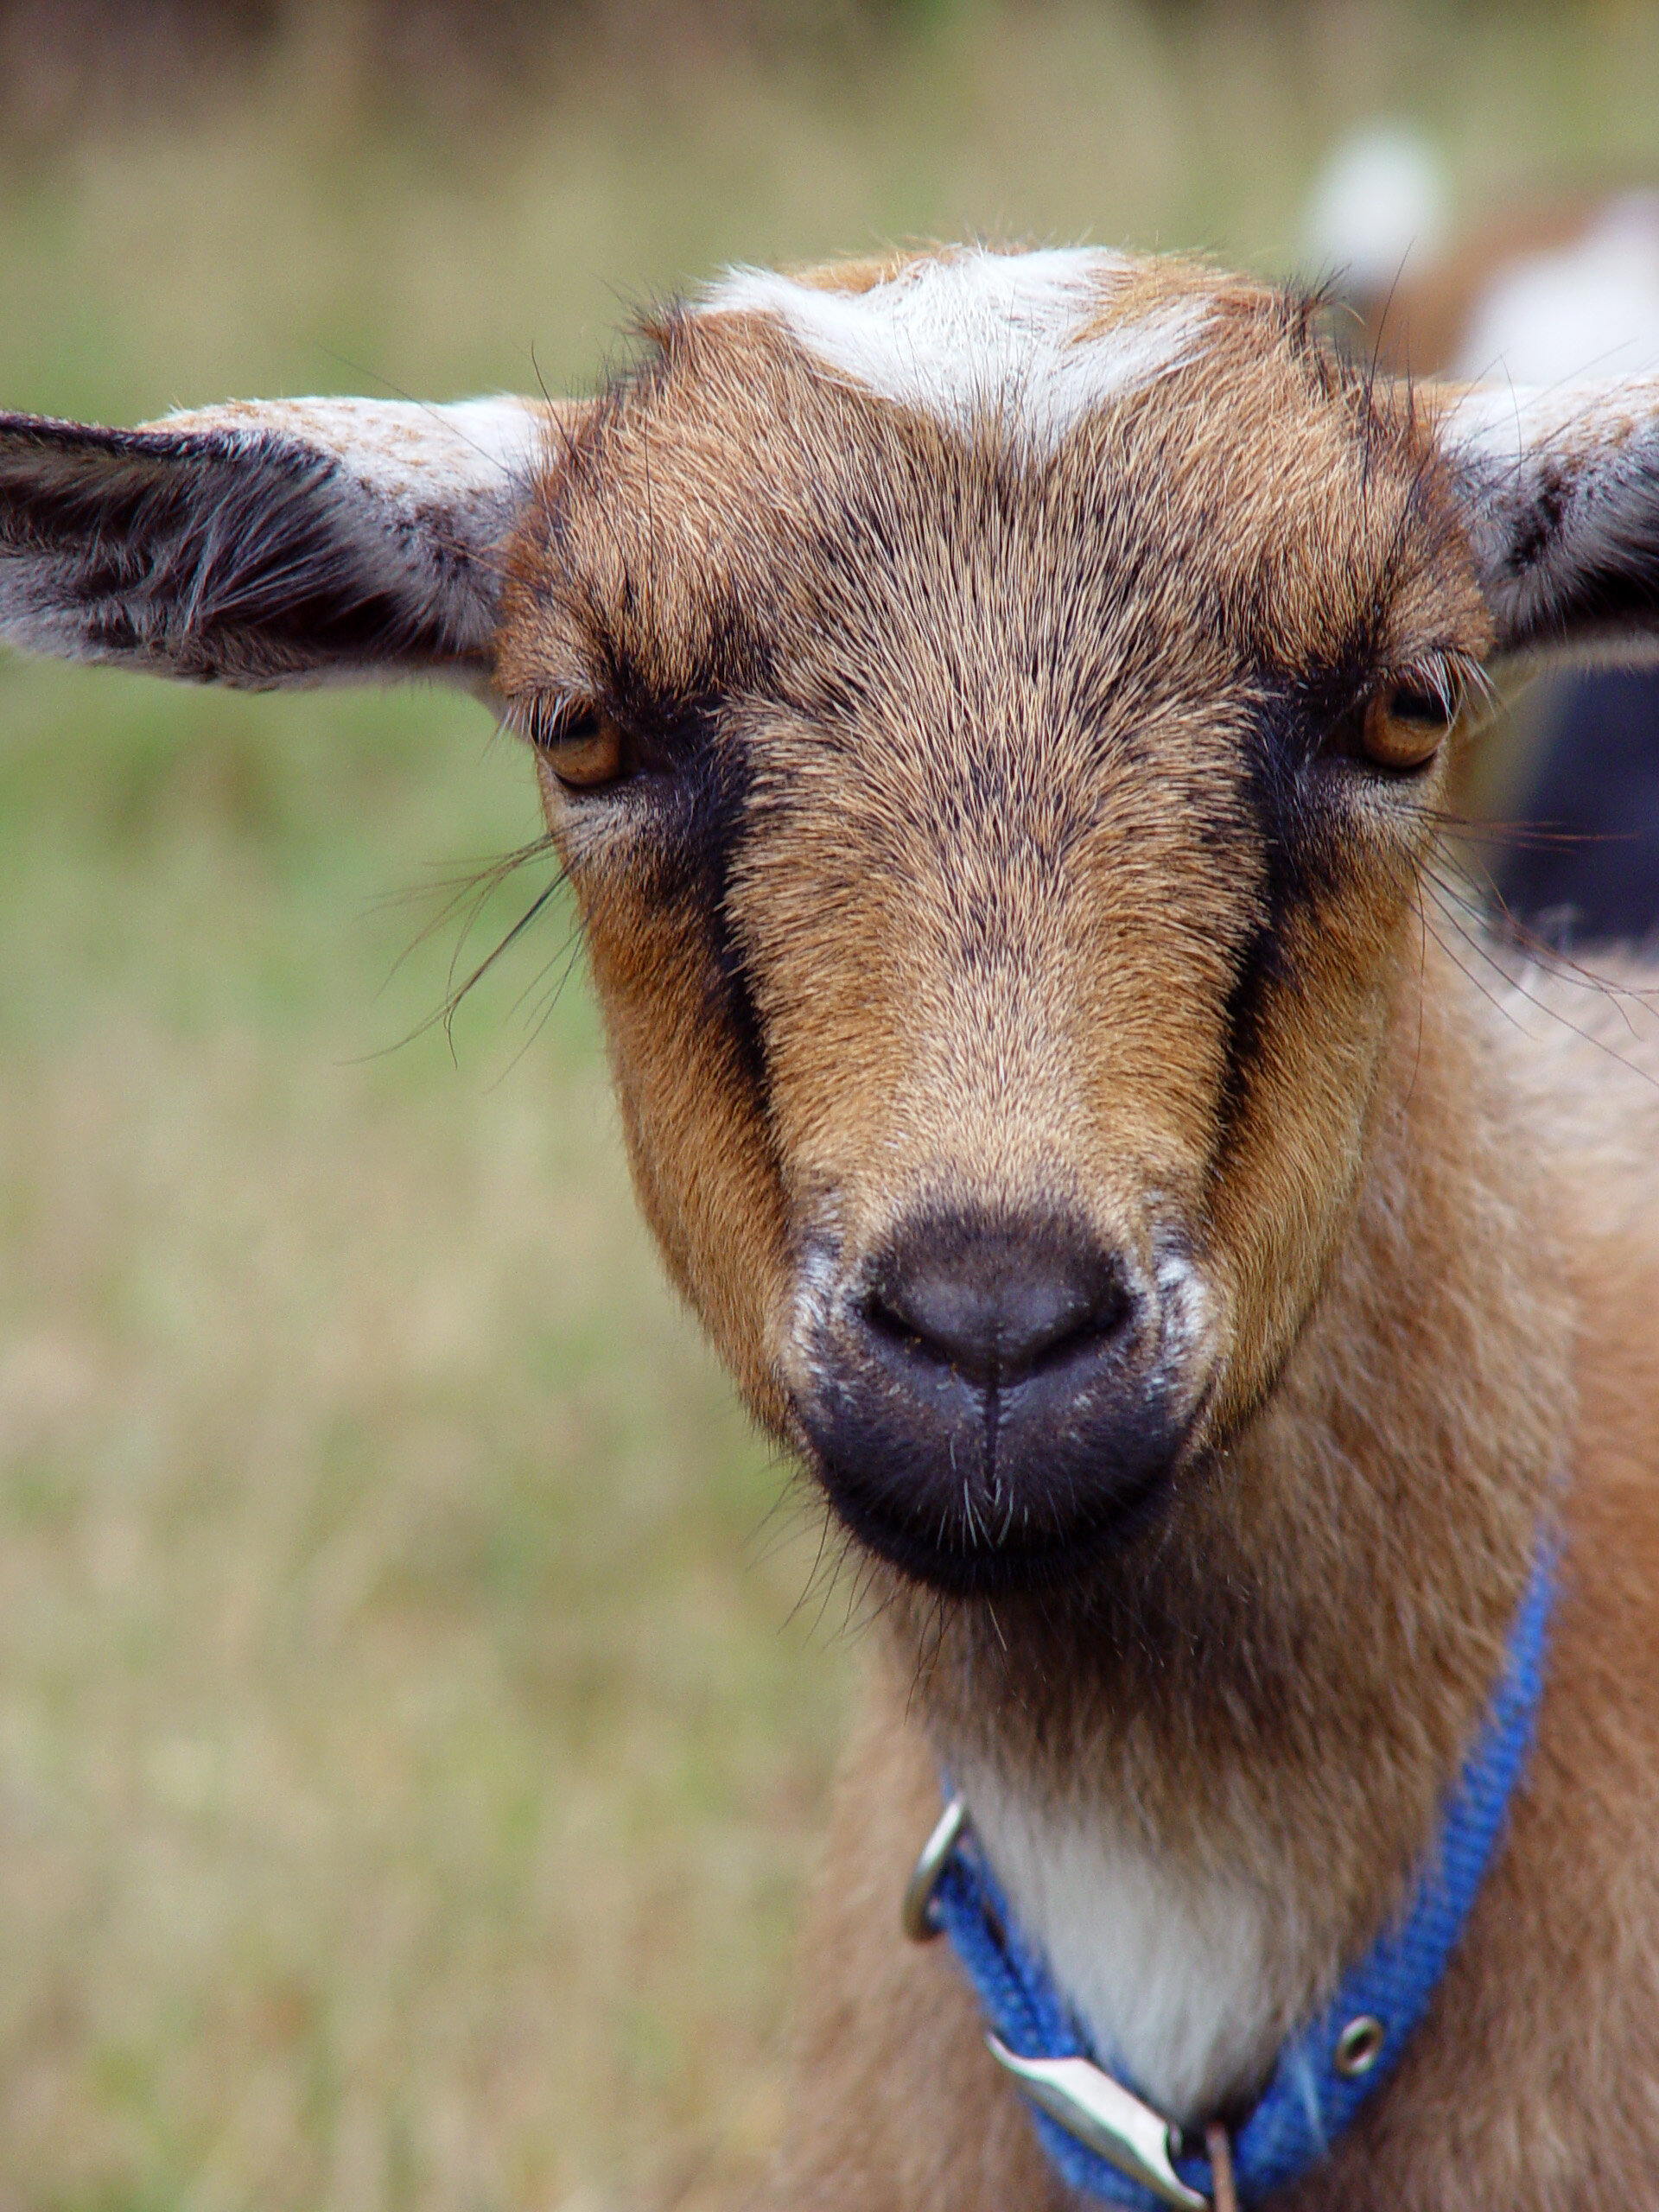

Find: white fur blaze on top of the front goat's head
[703,248,1208,445]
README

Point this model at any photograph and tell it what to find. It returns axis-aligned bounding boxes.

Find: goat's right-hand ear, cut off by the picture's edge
[1440,378,1659,659]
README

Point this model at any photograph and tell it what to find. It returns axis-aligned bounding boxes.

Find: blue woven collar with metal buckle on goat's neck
[905,1544,1555,2212]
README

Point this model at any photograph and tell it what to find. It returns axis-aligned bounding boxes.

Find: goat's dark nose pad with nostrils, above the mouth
[865,1219,1130,1382]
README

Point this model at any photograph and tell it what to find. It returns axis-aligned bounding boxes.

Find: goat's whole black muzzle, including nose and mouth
[798,1208,1185,1591]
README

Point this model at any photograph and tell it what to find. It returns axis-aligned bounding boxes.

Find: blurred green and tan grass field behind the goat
[0,4,1659,2212]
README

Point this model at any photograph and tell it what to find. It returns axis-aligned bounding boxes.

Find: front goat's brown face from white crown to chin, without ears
[498,257,1491,1591]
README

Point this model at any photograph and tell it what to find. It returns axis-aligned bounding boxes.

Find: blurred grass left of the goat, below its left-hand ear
[0,668,838,2205]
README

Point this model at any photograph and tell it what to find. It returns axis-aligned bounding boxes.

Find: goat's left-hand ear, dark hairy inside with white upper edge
[0,400,556,688]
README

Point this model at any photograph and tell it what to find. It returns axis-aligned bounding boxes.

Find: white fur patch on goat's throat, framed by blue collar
[957,1772,1285,2126]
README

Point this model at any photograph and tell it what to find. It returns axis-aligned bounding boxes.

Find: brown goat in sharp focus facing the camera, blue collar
[0,248,1659,2212]
